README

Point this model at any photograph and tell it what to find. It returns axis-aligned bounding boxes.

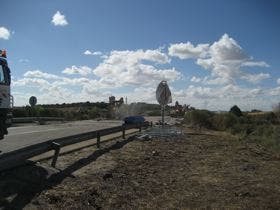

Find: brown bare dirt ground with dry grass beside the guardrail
[0,127,280,209]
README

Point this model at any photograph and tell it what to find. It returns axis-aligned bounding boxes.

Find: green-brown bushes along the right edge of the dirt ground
[184,104,280,151]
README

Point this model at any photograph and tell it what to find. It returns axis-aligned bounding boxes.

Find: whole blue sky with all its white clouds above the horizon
[0,0,280,111]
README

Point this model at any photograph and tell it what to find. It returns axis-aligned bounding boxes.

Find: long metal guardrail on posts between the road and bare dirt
[0,122,150,171]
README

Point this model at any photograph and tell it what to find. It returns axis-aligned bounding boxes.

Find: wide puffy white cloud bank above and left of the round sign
[14,49,177,94]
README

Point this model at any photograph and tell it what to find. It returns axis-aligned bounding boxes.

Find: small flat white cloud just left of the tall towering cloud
[168,42,209,59]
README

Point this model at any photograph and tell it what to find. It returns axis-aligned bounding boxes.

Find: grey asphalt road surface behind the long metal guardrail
[0,117,173,154]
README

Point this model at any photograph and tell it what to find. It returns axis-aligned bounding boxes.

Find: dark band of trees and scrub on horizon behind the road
[12,102,164,120]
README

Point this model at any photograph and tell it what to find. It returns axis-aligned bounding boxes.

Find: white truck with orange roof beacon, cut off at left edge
[0,50,13,140]
